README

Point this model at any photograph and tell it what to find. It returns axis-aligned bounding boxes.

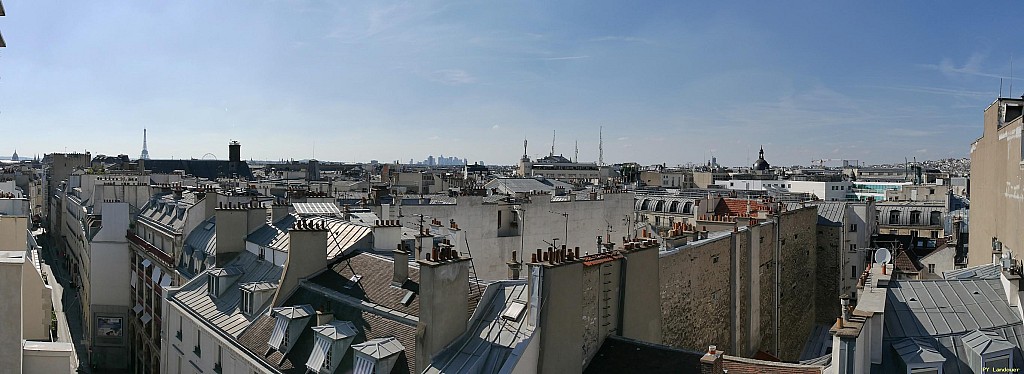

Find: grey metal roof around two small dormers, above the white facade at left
[169,248,282,338]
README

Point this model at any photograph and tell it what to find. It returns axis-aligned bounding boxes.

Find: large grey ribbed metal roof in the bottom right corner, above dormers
[874,279,1024,374]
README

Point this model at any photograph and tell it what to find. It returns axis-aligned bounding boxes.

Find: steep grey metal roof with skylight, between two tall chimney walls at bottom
[424,281,534,373]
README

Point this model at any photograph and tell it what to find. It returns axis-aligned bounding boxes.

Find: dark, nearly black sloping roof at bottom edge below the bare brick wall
[584,335,704,374]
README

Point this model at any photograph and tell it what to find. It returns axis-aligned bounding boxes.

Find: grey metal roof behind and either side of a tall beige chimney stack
[246,214,373,259]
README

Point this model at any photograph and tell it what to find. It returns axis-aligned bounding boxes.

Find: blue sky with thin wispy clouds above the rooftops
[0,0,1024,165]
